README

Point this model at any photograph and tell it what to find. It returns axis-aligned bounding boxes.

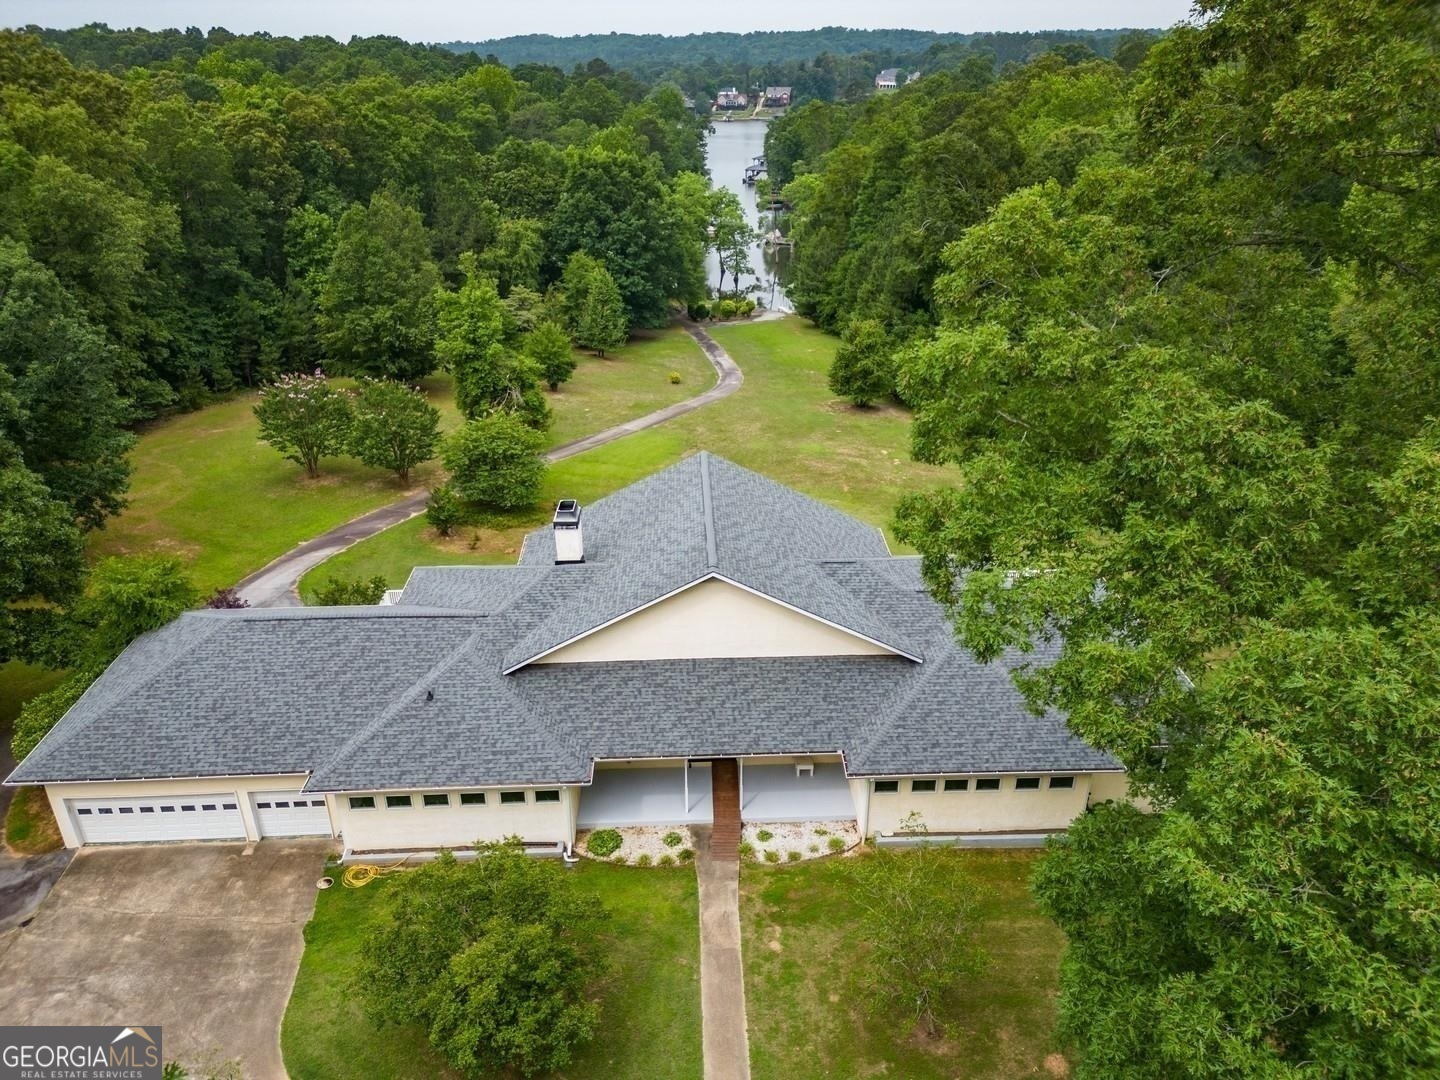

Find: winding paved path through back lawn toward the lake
[235,320,744,608]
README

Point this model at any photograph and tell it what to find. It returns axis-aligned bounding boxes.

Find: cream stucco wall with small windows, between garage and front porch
[333,788,575,851]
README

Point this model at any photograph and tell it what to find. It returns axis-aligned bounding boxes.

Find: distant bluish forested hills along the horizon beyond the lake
[448,26,1158,104]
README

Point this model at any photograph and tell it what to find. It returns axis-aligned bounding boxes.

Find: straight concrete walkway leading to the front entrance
[690,825,750,1080]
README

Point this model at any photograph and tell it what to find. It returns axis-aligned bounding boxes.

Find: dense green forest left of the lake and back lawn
[0,26,713,658]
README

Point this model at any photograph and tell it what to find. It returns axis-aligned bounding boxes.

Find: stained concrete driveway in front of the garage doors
[0,840,333,1080]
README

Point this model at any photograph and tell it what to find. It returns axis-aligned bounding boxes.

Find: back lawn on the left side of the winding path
[91,327,713,592]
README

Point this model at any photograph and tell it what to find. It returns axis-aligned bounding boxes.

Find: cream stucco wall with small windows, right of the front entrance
[857,773,1090,835]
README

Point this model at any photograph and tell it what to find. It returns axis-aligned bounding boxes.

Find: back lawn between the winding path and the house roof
[301,318,955,595]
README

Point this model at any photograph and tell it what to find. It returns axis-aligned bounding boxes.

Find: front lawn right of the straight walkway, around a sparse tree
[740,851,1068,1080]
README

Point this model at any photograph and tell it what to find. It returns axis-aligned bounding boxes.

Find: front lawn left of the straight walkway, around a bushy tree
[281,861,701,1080]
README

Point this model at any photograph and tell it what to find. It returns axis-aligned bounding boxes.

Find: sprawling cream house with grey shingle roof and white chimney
[6,454,1126,852]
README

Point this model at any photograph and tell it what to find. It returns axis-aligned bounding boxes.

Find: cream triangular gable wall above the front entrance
[536,579,890,664]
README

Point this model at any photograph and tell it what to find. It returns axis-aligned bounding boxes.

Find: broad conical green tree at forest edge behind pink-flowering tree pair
[317,192,439,379]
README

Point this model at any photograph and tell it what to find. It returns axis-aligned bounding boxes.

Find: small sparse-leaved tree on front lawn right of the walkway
[848,845,985,1035]
